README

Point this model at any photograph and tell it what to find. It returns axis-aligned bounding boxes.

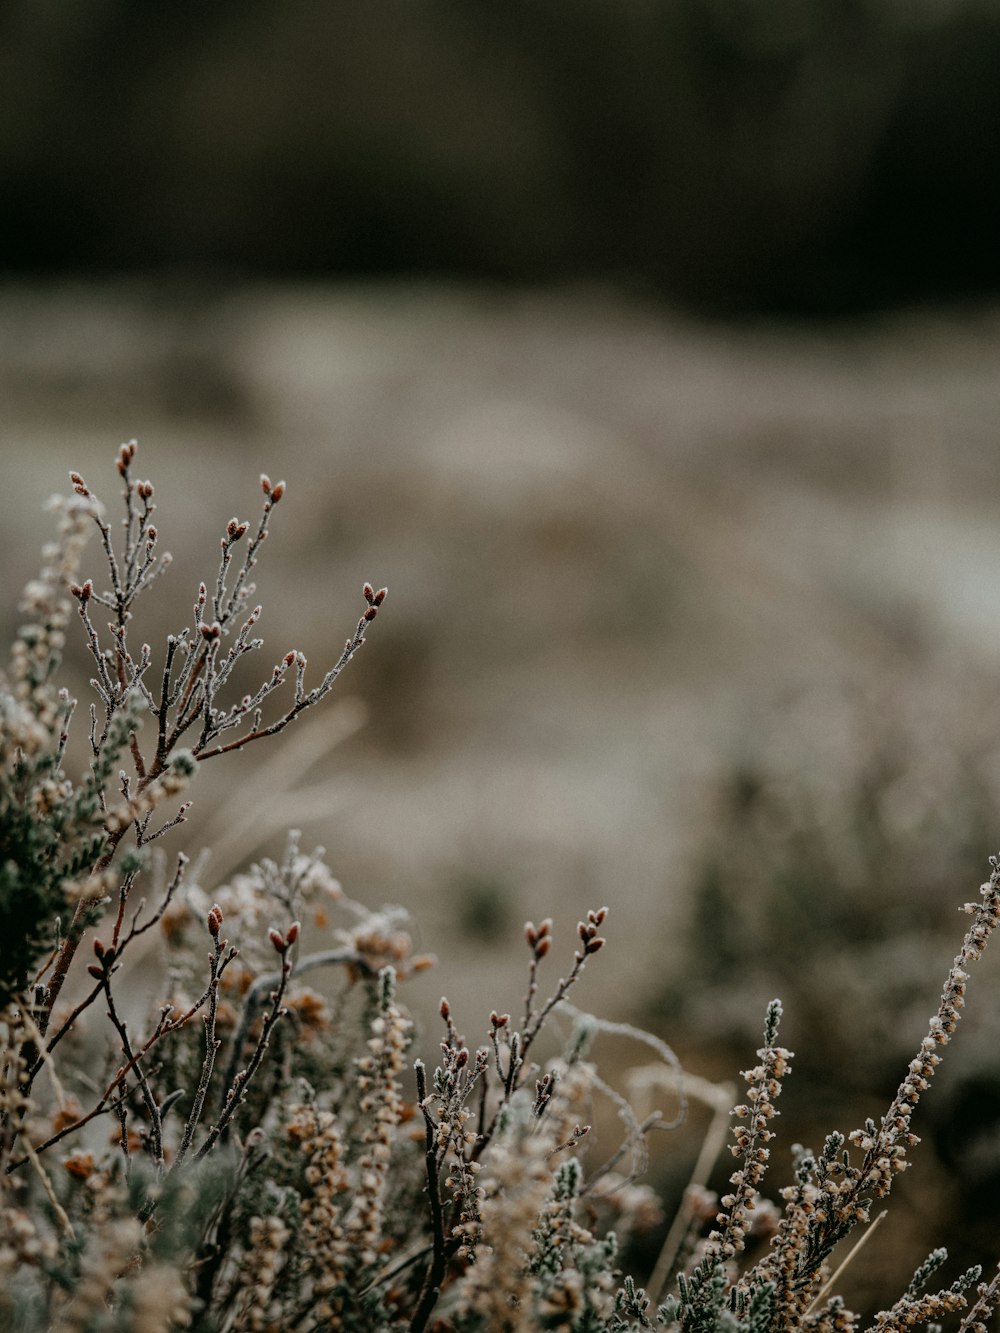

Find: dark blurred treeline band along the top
[0,0,1000,313]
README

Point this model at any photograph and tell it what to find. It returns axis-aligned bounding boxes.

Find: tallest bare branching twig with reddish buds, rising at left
[30,441,385,1033]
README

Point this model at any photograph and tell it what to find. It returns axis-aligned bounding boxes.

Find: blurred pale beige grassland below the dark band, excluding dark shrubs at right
[0,285,1000,1311]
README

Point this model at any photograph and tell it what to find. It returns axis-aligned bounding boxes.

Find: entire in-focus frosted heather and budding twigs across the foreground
[0,444,1000,1333]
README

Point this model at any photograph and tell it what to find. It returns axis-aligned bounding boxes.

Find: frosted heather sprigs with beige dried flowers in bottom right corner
[661,857,1000,1333]
